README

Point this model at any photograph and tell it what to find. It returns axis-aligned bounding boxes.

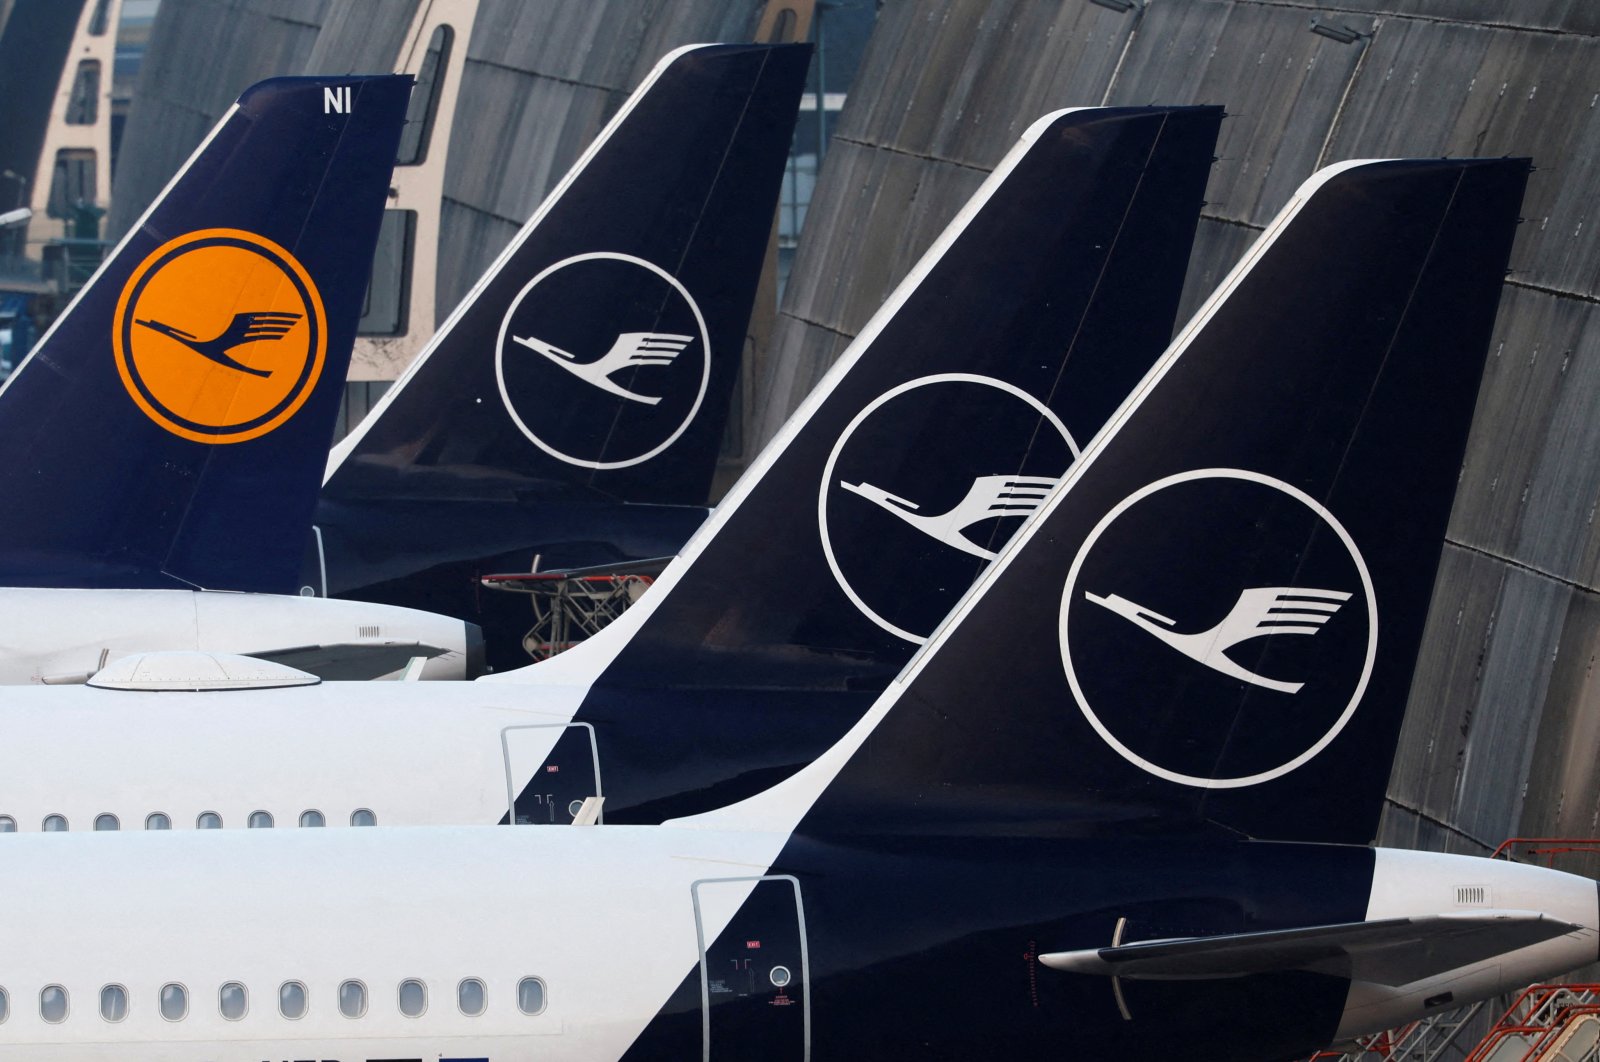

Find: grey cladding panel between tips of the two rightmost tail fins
[1110,3,1363,226]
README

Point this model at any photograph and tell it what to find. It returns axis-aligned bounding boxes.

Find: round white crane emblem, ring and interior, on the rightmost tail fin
[1056,467,1379,790]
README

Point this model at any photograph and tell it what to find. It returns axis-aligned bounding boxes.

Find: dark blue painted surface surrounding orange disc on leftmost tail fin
[0,75,411,592]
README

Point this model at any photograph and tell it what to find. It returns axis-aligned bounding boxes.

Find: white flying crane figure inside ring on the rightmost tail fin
[1083,587,1350,693]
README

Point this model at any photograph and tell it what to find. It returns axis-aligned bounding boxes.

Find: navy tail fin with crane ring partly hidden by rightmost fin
[547,107,1222,674]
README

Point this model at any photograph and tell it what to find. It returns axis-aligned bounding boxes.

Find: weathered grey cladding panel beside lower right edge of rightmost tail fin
[1382,545,1561,848]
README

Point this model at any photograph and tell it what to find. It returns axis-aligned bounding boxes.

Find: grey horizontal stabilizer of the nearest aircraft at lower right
[1038,910,1579,987]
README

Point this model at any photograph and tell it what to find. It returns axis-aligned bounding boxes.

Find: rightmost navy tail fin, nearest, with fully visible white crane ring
[768,160,1528,843]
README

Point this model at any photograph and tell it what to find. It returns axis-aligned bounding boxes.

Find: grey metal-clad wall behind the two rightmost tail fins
[760,0,1600,851]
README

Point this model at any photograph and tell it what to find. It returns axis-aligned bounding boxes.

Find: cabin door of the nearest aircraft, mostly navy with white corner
[693,875,811,1062]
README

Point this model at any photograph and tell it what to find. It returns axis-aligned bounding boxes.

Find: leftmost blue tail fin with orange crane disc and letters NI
[0,75,411,592]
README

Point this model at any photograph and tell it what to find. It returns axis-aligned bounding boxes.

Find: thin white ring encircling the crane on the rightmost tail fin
[1058,469,1378,789]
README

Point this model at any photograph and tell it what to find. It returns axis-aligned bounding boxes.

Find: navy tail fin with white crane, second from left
[325,45,810,505]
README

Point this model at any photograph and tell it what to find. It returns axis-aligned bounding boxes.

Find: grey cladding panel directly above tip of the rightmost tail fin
[1328,19,1600,297]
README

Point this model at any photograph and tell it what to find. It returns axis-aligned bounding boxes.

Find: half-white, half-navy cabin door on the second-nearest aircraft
[501,723,605,825]
